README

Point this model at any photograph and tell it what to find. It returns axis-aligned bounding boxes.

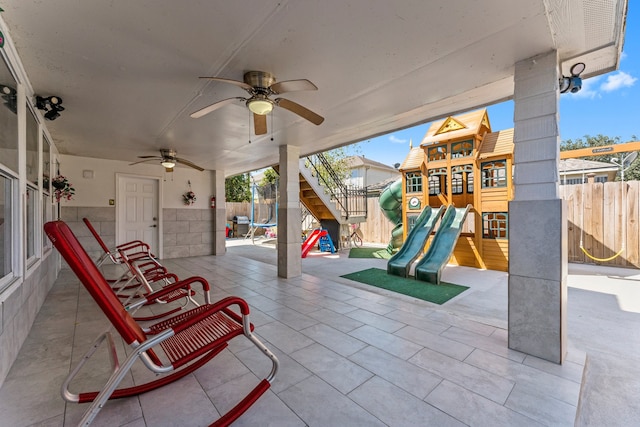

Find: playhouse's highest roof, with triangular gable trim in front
[420,109,491,146]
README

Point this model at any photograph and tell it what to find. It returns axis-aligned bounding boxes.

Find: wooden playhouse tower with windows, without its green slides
[400,109,514,271]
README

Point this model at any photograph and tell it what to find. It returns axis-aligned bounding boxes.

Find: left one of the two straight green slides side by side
[387,206,444,277]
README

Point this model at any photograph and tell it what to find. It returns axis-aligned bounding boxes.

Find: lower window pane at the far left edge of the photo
[0,172,15,290]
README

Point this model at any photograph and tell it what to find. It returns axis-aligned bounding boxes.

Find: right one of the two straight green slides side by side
[415,205,471,285]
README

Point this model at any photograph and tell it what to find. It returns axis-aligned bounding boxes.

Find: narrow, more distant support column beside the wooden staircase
[278,145,302,278]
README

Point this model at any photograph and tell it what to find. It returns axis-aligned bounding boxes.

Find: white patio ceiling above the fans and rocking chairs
[1,0,627,175]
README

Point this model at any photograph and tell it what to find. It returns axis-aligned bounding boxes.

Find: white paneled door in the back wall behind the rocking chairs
[116,176,160,255]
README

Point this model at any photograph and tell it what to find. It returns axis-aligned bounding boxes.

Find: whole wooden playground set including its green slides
[380,109,514,283]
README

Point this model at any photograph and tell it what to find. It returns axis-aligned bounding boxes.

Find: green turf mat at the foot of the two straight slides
[340,268,469,304]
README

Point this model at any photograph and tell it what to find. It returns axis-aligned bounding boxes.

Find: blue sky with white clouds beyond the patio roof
[356,1,640,166]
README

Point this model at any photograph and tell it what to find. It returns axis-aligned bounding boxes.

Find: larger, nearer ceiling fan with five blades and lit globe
[191,71,324,135]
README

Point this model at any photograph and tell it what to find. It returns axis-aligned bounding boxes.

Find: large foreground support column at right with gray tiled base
[509,51,567,363]
